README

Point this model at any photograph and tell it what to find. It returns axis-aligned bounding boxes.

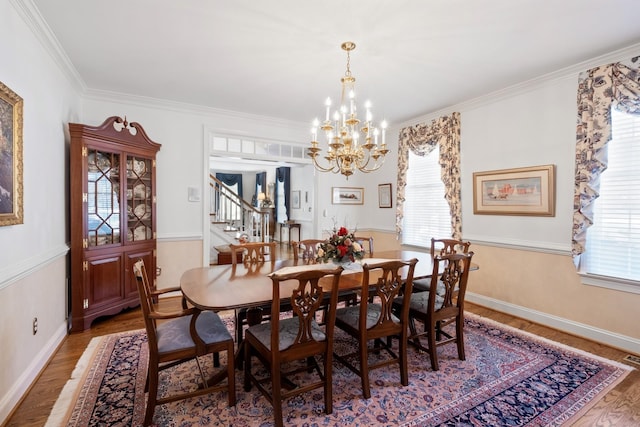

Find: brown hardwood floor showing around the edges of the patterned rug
[3,247,640,427]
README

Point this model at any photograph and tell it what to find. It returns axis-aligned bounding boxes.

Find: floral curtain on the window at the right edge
[571,57,640,258]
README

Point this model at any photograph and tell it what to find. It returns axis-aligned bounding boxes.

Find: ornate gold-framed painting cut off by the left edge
[0,82,23,226]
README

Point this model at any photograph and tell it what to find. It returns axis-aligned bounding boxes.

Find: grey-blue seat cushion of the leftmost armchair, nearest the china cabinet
[156,311,232,353]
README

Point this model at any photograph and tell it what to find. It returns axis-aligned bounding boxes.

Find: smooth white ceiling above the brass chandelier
[32,0,640,125]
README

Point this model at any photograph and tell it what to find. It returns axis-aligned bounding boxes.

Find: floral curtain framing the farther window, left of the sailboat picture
[396,112,462,239]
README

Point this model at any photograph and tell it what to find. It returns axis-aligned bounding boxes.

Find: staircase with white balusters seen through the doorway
[209,174,270,264]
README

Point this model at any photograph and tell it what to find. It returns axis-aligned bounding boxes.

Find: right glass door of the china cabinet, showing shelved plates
[127,155,153,242]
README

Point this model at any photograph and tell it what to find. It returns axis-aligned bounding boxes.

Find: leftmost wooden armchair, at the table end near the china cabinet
[133,259,236,426]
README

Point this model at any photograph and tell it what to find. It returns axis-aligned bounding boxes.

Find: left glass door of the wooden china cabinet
[87,149,122,247]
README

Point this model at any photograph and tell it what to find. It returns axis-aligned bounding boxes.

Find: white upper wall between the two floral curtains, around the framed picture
[460,73,578,251]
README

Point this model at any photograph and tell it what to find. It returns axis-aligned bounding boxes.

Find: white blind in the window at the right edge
[580,108,640,281]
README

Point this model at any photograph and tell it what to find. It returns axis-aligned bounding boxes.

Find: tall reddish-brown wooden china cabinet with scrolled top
[69,116,160,332]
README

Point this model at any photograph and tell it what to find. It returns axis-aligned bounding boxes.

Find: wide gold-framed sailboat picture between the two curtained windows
[473,165,555,216]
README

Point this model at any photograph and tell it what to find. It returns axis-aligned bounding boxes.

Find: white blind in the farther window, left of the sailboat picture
[402,148,452,248]
